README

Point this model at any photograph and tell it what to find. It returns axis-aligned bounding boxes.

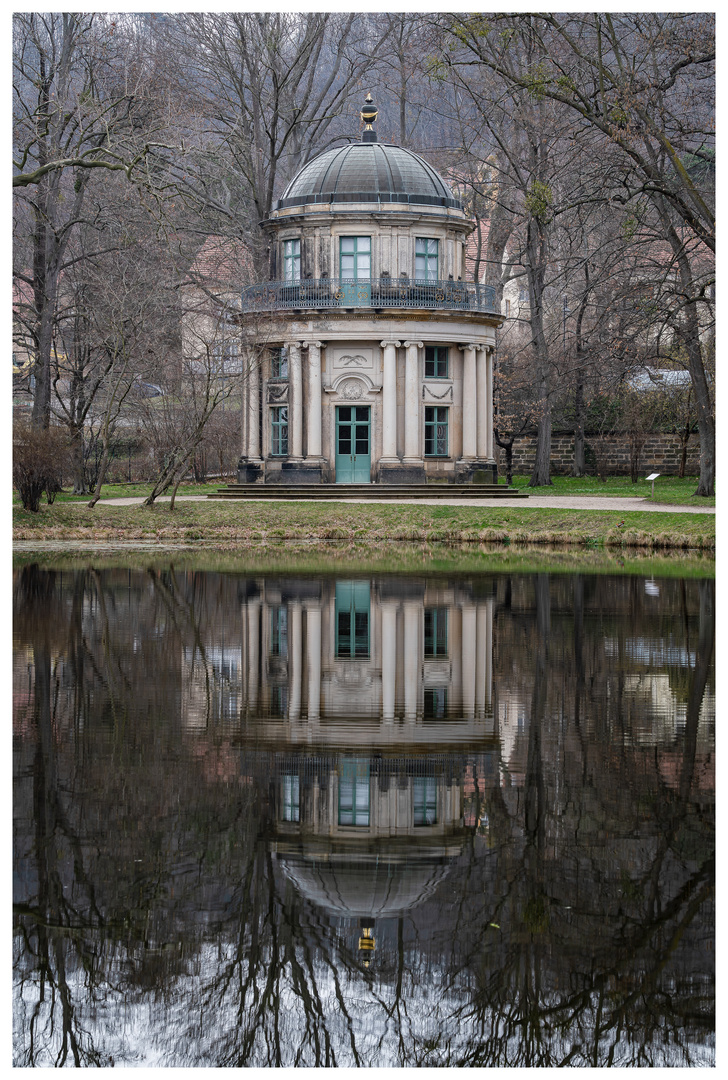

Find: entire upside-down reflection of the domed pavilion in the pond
[181,579,497,963]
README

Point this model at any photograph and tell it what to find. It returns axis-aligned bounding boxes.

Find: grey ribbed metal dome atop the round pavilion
[275,142,462,210]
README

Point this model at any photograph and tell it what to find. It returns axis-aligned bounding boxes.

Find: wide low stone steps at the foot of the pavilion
[207,484,528,500]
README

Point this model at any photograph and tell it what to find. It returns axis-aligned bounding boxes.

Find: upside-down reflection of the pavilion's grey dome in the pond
[279,855,448,919]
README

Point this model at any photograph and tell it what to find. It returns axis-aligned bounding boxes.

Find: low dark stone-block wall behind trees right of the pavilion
[498,432,700,476]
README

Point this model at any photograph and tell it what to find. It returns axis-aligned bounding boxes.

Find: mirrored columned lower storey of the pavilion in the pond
[243,579,493,744]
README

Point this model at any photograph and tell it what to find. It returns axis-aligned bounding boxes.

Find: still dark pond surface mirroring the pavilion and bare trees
[13,566,715,1066]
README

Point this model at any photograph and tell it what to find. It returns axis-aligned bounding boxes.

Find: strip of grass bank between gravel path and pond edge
[13,501,715,551]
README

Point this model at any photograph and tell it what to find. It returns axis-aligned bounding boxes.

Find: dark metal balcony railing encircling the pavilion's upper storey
[242,278,500,314]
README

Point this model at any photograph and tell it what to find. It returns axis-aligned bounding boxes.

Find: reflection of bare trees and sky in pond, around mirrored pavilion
[14,568,714,1066]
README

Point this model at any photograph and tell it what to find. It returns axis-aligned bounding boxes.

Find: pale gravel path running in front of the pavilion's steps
[100,495,715,514]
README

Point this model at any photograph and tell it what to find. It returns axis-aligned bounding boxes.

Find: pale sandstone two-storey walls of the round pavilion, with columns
[239,123,502,484]
